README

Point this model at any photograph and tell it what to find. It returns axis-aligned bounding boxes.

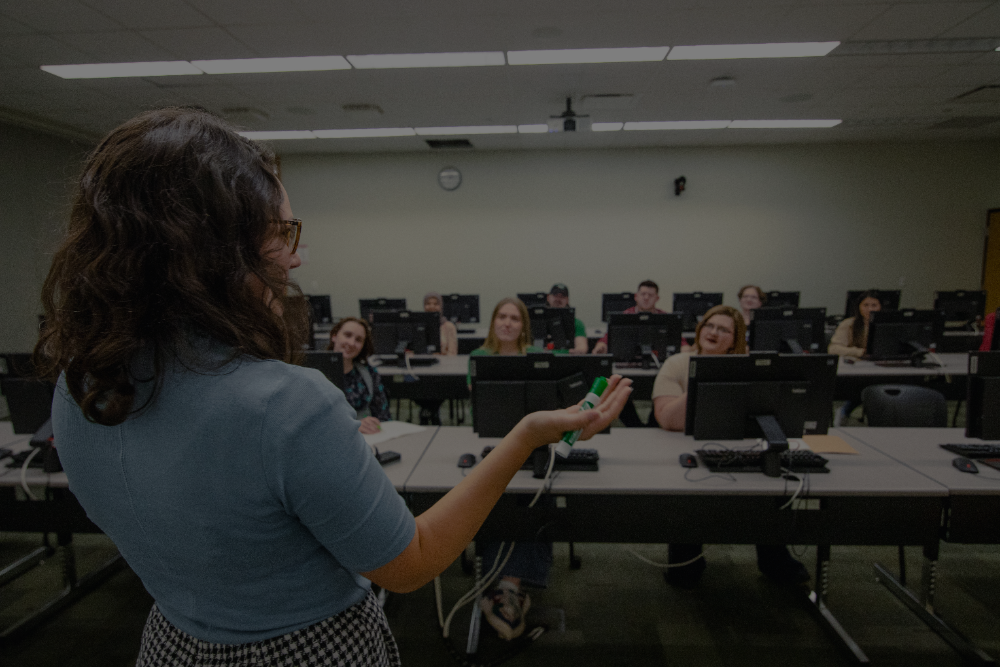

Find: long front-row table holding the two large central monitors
[404,426,947,663]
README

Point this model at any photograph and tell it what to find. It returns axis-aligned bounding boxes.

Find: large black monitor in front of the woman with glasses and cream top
[684,352,838,476]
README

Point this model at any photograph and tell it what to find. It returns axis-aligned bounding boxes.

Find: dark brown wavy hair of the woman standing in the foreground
[35,108,308,426]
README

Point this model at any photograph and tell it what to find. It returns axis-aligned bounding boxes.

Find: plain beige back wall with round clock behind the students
[282,143,1000,325]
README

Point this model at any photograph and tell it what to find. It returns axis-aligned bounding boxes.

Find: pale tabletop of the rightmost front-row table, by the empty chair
[839,428,1000,495]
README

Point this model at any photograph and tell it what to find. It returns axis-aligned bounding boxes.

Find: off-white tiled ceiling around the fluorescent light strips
[0,0,1000,153]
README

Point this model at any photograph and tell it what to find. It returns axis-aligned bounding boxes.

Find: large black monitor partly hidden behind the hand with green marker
[469,353,613,438]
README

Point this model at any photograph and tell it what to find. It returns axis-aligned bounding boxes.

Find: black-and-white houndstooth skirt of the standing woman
[136,591,400,667]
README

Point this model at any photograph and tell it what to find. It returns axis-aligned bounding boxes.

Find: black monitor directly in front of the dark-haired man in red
[608,313,684,368]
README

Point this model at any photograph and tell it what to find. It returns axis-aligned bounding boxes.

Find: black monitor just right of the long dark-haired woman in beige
[865,308,944,366]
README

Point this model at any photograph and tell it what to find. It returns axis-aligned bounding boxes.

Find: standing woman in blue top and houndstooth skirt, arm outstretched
[35,109,629,667]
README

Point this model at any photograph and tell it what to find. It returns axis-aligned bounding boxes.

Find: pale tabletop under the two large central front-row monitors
[405,426,947,496]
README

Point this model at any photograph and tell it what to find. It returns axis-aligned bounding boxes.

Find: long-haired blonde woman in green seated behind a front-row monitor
[469,298,554,641]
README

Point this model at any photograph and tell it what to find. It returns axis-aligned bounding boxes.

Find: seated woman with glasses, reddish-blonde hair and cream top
[653,306,809,587]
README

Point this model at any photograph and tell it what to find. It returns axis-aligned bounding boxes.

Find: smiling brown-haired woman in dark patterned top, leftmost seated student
[326,317,392,435]
